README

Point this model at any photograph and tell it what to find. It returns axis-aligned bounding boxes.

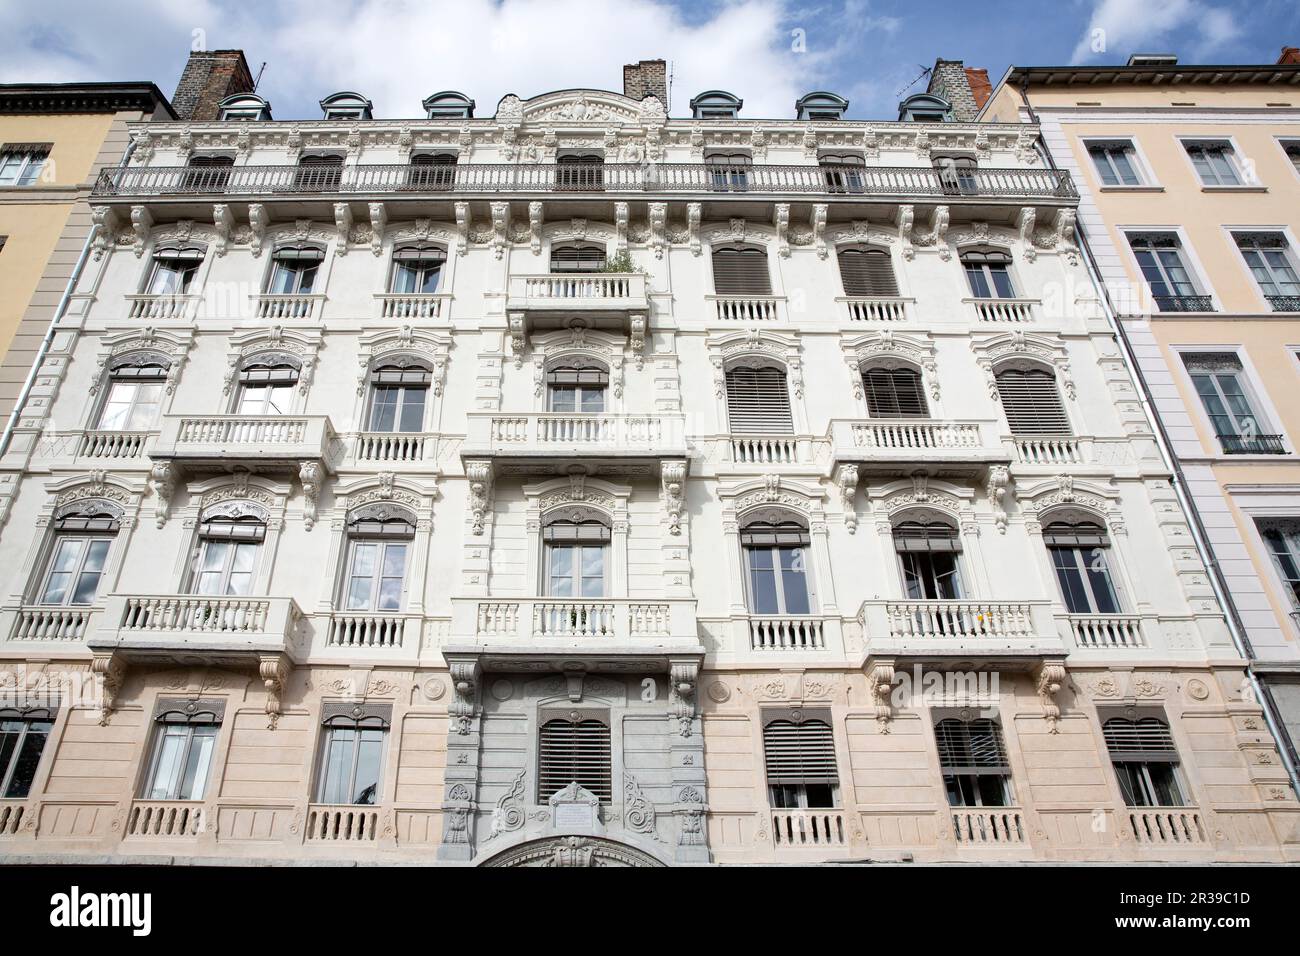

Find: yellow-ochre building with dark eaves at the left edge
[0,83,176,420]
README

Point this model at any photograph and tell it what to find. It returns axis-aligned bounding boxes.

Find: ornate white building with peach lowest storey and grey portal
[0,55,1300,865]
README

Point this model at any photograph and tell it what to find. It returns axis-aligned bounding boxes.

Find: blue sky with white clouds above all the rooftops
[0,0,1300,120]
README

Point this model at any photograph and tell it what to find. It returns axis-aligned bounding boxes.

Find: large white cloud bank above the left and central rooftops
[0,0,898,118]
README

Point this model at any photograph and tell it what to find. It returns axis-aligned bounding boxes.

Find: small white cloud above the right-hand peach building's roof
[1070,0,1242,64]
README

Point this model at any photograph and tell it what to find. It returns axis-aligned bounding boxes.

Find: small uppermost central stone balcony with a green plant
[506,272,650,334]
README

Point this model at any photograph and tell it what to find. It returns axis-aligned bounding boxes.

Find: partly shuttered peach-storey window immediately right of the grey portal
[763,710,840,811]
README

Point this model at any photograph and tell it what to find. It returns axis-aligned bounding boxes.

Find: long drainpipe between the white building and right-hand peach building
[1019,78,1300,793]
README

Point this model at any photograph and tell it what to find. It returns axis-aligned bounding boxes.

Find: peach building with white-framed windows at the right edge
[984,48,1300,771]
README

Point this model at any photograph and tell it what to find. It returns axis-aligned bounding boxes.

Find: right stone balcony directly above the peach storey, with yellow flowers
[859,600,1067,662]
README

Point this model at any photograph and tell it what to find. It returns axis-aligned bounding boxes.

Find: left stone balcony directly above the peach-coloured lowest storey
[86,594,302,666]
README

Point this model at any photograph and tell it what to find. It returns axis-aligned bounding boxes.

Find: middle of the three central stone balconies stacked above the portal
[460,412,686,473]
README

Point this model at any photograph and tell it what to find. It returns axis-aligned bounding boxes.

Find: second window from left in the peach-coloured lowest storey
[140,700,225,800]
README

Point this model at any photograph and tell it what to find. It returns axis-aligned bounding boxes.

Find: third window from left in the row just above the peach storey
[343,506,415,611]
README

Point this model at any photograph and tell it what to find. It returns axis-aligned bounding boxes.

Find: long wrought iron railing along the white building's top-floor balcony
[92,163,1078,200]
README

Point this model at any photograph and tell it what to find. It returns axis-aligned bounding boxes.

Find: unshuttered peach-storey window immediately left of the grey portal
[316,704,393,806]
